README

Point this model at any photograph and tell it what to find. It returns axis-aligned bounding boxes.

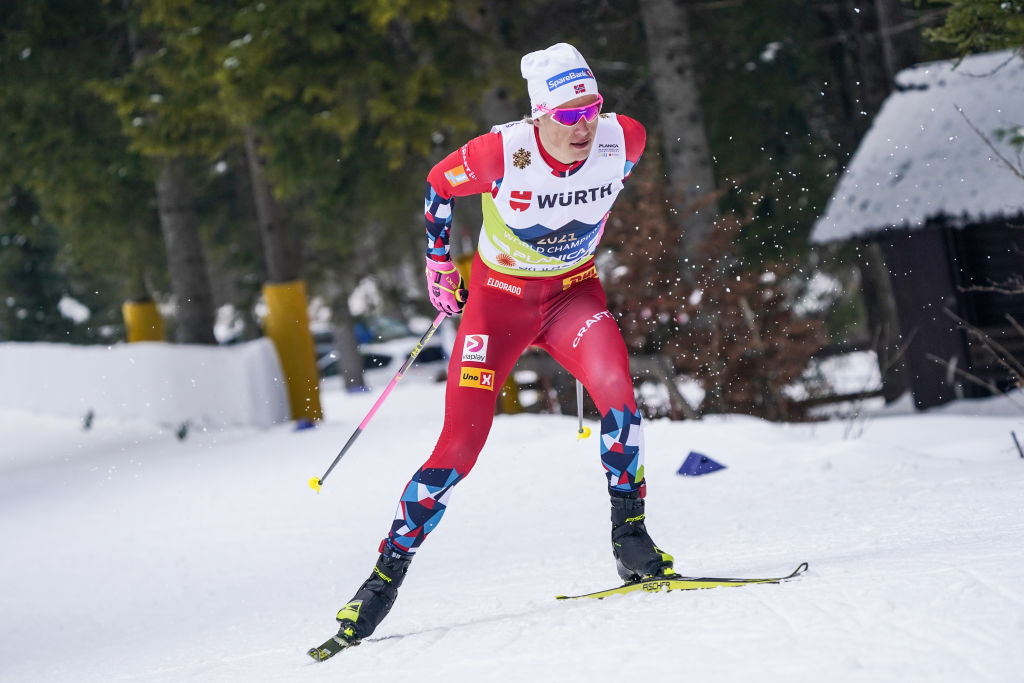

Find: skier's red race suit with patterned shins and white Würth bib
[381,114,646,555]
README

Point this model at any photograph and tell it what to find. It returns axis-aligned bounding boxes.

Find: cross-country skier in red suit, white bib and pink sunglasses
[309,43,673,659]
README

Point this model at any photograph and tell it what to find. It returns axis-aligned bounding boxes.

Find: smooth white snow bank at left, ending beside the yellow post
[0,339,290,427]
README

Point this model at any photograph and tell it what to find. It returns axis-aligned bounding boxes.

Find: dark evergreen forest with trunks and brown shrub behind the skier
[0,0,1024,418]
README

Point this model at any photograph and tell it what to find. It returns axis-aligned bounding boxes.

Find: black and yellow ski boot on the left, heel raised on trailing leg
[306,554,413,660]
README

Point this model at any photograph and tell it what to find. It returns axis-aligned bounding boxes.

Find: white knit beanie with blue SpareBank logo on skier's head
[520,43,597,117]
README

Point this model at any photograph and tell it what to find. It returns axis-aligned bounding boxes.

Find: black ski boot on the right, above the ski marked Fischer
[610,490,675,583]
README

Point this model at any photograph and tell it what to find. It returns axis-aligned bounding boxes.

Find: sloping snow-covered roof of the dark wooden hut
[811,50,1024,243]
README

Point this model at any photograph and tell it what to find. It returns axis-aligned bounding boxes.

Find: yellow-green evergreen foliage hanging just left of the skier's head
[121,0,501,383]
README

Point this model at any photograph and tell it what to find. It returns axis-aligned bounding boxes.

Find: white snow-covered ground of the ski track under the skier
[0,362,1024,683]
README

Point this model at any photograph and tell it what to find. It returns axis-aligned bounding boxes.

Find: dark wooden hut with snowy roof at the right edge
[811,51,1024,408]
